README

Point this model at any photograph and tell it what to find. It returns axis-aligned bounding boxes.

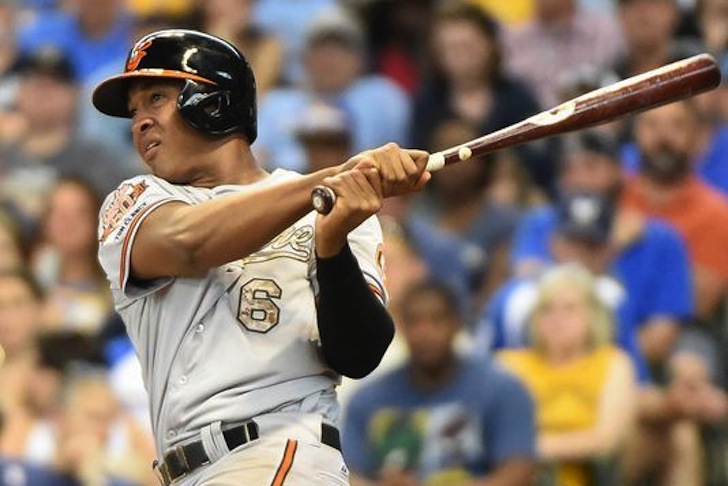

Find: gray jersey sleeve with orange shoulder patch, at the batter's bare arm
[98,176,188,300]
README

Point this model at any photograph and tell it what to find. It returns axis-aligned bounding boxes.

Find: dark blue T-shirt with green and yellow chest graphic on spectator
[343,358,536,484]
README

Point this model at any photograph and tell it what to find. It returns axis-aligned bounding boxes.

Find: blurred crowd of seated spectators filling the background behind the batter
[0,0,728,486]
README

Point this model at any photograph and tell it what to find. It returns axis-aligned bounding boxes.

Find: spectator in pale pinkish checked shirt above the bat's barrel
[504,0,624,107]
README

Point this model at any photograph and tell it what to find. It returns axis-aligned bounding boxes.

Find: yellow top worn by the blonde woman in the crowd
[498,346,619,486]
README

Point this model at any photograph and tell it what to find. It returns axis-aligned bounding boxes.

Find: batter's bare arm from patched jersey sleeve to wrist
[166,168,337,273]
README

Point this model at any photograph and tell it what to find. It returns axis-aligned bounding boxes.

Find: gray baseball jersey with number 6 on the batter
[99,170,386,453]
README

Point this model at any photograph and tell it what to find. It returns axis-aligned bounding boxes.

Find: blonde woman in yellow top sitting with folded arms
[498,264,640,486]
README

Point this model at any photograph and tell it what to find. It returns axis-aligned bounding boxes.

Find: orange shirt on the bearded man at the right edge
[622,176,728,280]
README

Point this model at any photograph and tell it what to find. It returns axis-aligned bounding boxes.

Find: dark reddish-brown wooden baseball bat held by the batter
[311,54,720,214]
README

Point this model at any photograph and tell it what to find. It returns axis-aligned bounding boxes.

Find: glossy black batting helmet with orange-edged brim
[93,29,258,143]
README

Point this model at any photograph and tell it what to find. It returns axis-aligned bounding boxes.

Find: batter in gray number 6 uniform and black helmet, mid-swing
[93,30,429,486]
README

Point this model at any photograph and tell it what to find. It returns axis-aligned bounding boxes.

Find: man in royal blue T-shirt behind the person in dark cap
[511,131,694,378]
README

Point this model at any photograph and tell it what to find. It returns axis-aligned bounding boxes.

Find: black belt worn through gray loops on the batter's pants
[153,420,341,486]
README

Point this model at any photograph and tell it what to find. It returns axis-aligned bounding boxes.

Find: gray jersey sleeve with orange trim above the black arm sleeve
[349,216,389,305]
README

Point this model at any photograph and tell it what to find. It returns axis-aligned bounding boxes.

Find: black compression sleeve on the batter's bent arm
[316,244,394,378]
